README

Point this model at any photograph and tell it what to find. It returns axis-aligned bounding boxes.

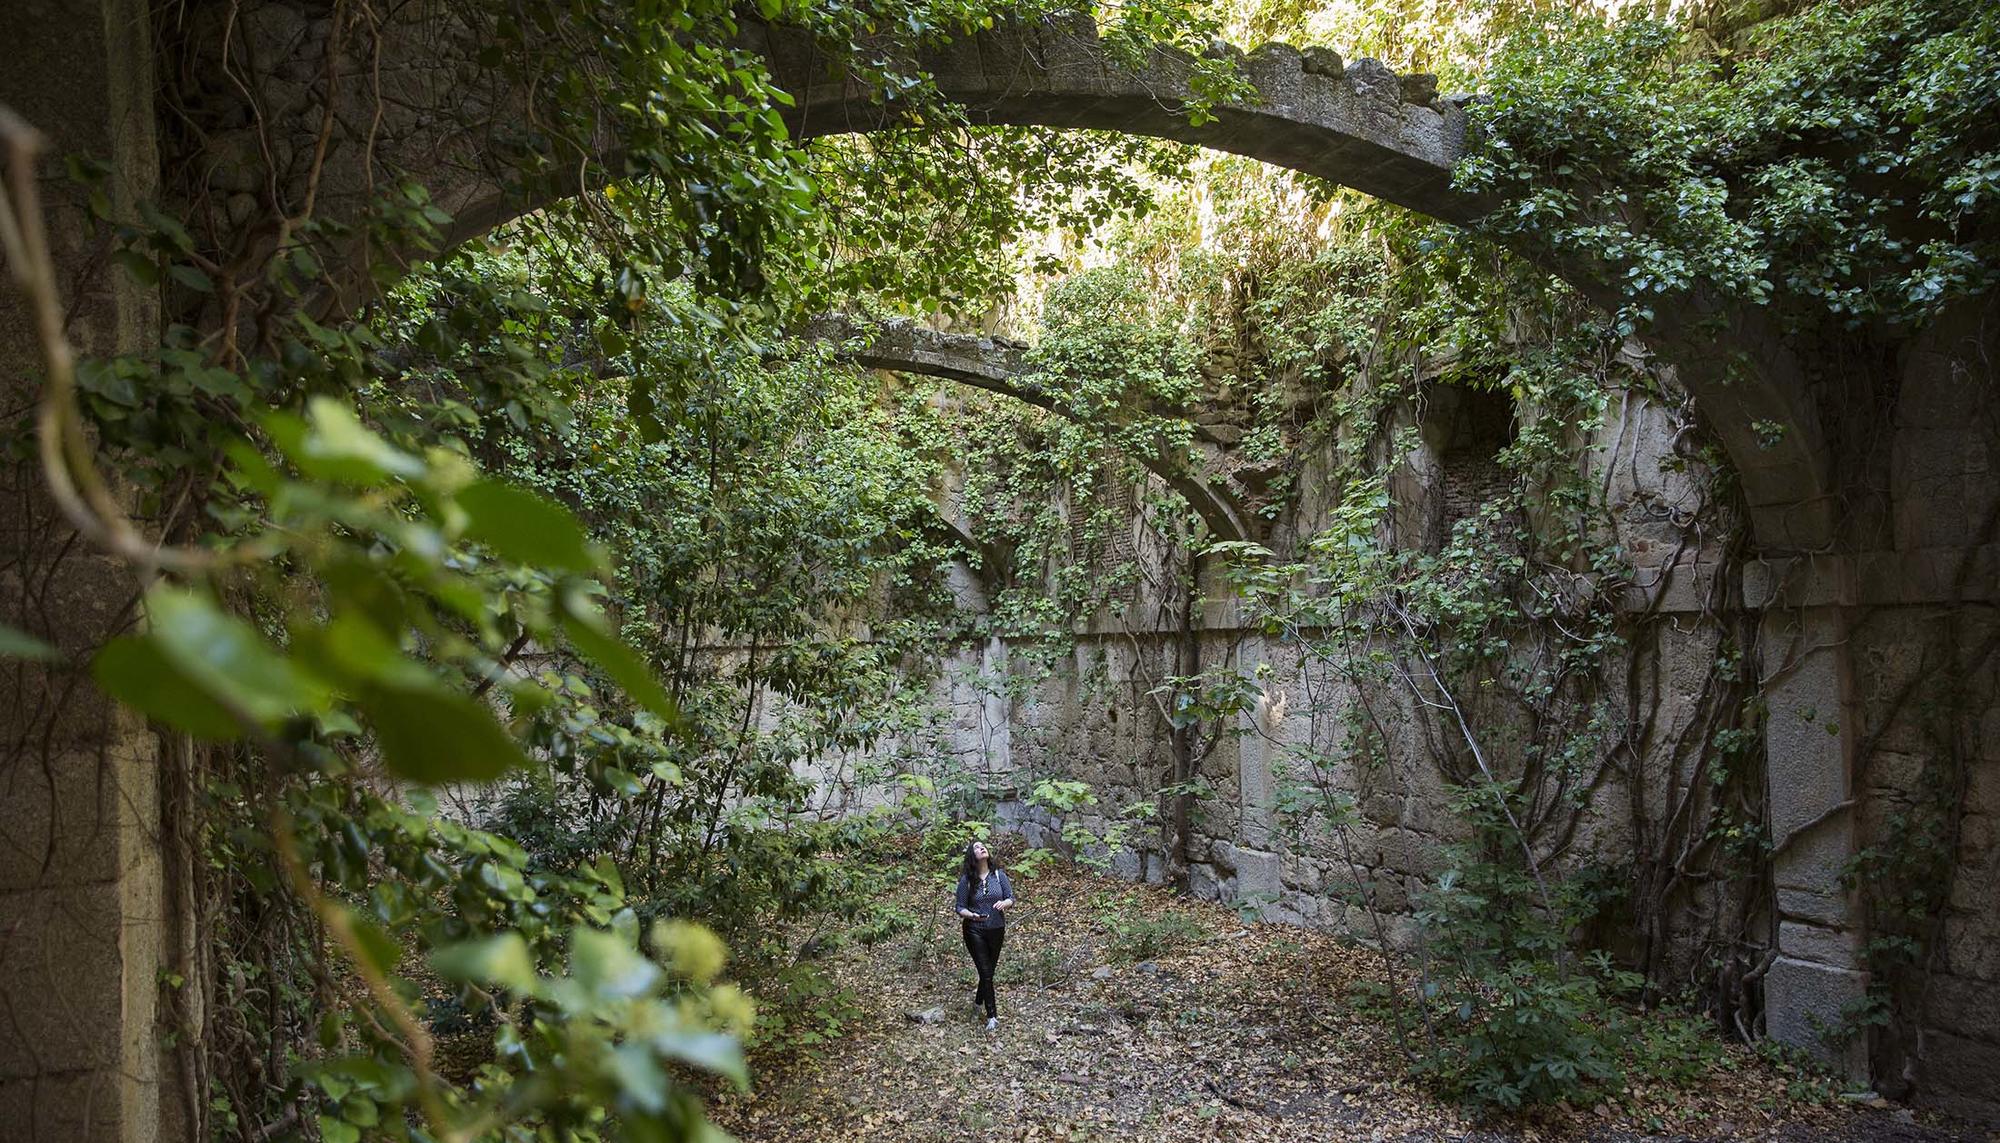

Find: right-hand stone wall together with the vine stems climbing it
[900,331,2000,1117]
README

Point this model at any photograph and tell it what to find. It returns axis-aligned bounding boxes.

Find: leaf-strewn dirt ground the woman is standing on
[714,869,2000,1143]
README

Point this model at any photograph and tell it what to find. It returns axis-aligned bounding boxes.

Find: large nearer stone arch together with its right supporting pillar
[332,18,1866,1045]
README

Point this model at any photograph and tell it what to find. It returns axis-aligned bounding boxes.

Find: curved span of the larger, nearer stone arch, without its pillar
[430,16,1840,554]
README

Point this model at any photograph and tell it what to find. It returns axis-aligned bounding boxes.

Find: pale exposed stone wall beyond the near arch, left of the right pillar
[900,369,1720,931]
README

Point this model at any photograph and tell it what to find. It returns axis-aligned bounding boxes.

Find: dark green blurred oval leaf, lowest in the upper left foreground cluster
[358,685,528,781]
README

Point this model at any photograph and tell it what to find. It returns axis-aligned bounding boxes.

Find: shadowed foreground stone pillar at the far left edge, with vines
[0,0,162,1143]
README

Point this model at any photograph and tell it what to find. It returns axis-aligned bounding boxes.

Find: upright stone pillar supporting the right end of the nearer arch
[1744,558,1868,1079]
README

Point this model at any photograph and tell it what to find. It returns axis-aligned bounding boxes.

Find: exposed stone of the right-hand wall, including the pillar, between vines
[888,353,2000,1117]
